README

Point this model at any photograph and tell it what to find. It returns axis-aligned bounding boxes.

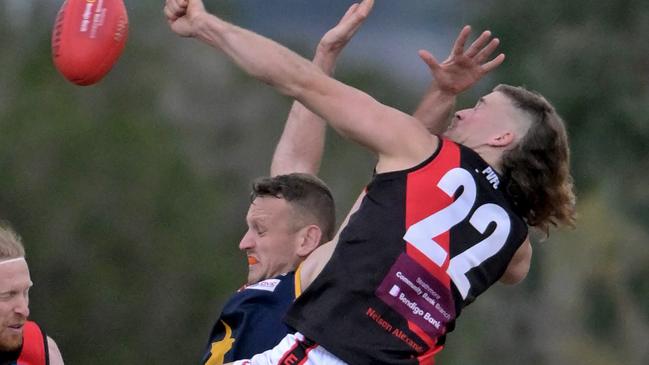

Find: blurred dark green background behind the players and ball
[0,0,649,365]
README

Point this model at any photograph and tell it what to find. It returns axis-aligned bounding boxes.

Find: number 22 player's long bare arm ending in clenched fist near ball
[165,0,438,172]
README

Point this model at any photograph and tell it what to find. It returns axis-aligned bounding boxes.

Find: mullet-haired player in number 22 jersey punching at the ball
[165,0,574,365]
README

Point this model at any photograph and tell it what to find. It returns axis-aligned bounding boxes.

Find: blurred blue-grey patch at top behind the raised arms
[237,0,468,88]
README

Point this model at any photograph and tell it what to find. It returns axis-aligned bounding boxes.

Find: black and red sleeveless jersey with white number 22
[286,140,527,364]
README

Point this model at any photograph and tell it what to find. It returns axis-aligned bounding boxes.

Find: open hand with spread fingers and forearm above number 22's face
[413,25,505,134]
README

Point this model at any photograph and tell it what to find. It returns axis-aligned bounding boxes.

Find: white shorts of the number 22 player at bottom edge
[232,332,347,365]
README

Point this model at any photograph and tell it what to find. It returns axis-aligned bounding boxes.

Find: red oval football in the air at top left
[52,0,128,85]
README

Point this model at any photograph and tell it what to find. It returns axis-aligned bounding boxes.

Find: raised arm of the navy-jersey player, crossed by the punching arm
[270,4,371,176]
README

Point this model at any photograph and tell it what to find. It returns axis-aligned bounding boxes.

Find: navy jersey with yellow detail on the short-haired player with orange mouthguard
[202,272,300,365]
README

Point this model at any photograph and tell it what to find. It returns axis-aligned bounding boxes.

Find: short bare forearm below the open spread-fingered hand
[413,85,456,135]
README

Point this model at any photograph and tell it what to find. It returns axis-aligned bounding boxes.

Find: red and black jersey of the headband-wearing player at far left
[0,321,50,365]
